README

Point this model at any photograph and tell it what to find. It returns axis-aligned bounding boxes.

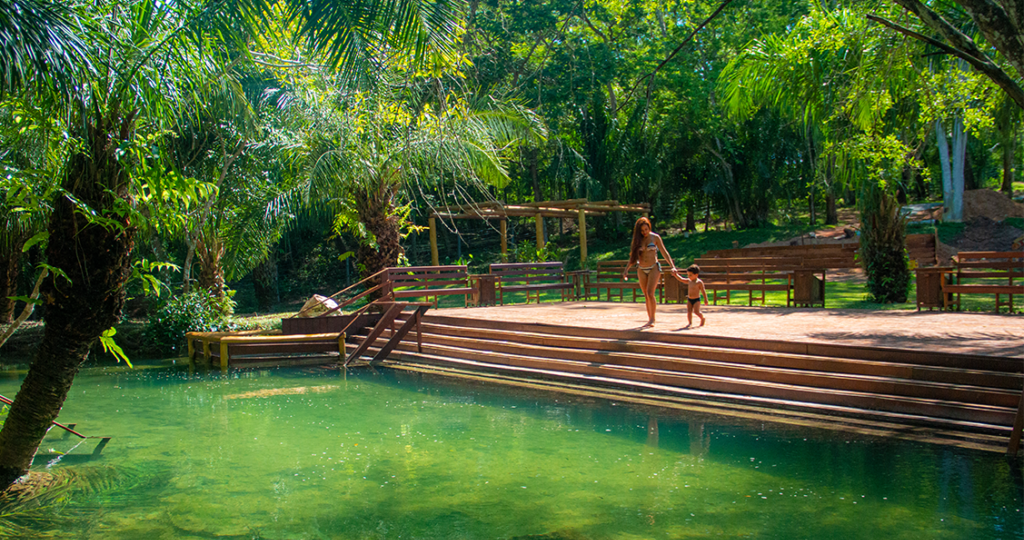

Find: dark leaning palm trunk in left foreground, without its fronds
[0,109,135,489]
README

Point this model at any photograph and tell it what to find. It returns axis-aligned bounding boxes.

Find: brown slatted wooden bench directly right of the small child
[694,257,826,307]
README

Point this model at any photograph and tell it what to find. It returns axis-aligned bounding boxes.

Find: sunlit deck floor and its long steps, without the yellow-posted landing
[350,302,1024,457]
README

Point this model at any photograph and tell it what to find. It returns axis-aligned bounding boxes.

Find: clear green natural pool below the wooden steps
[0,367,1024,540]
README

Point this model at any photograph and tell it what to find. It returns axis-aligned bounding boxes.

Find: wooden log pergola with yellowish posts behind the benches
[427,199,650,266]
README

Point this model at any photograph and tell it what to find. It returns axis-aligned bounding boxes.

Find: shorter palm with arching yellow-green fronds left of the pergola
[308,81,544,277]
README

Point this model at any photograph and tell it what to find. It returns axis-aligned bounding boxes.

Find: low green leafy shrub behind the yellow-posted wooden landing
[145,291,234,352]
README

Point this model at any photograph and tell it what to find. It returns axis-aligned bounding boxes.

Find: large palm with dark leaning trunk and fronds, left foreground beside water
[0,0,459,488]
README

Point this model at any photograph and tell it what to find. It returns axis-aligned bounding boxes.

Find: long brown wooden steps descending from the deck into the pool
[350,315,1024,453]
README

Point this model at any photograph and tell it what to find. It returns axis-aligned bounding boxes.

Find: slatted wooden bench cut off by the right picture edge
[942,251,1024,313]
